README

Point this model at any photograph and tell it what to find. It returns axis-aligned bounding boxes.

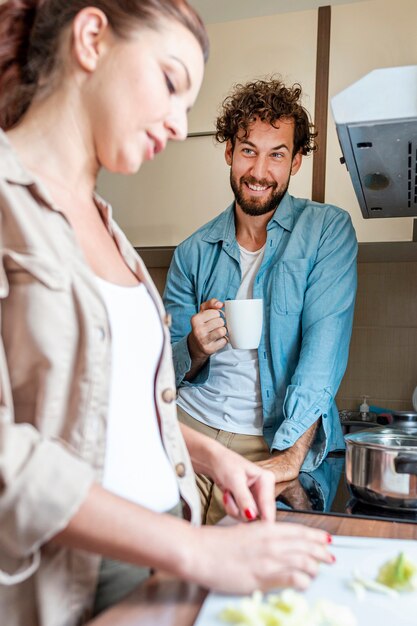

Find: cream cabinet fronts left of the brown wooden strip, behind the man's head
[99,11,317,246]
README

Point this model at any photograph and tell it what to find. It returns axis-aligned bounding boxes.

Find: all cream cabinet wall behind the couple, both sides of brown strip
[99,0,417,246]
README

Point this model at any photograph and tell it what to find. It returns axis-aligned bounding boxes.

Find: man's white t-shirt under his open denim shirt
[177,246,265,435]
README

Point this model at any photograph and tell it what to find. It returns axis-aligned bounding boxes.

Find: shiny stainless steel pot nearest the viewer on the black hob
[345,426,417,510]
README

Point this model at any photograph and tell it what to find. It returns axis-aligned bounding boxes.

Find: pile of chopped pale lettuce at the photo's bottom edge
[219,589,357,626]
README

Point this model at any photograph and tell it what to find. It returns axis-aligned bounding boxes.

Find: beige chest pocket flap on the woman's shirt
[3,250,69,291]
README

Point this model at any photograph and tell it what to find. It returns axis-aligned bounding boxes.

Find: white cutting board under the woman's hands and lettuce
[194,536,417,626]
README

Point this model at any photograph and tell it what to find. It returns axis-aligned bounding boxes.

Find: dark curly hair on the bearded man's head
[216,79,317,155]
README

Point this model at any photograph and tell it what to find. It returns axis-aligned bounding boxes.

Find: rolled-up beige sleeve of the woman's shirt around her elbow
[0,254,93,585]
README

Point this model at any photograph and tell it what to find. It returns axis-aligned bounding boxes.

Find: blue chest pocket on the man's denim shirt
[271,259,311,315]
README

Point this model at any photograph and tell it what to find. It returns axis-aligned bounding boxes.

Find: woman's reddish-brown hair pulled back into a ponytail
[0,0,208,130]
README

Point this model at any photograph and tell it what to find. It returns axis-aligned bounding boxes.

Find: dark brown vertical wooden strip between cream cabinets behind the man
[311,6,331,202]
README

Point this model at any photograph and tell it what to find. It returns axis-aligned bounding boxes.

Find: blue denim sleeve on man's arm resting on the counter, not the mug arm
[271,211,357,467]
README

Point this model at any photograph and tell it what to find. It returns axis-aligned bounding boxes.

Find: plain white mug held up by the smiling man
[224,298,263,350]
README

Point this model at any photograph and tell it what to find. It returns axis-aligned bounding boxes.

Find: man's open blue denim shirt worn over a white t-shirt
[164,193,357,471]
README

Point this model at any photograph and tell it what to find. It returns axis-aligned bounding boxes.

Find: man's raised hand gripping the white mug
[185,298,227,380]
